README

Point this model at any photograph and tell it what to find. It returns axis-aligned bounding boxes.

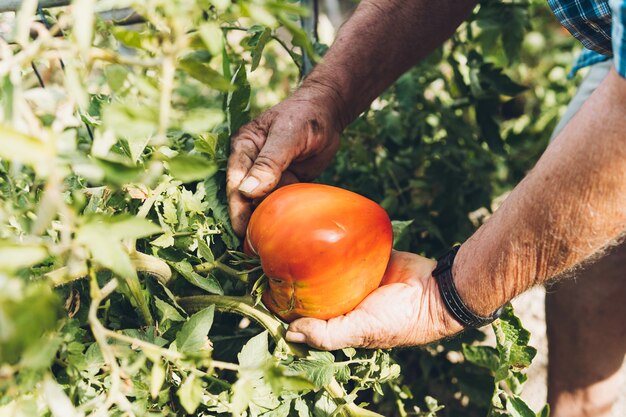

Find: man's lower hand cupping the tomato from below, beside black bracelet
[287,251,463,350]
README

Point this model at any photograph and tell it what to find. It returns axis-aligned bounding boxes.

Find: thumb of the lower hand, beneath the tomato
[286,310,366,350]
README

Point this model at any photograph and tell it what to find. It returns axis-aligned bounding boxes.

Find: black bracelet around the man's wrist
[433,246,504,327]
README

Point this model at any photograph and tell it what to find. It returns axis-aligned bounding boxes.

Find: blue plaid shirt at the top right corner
[548,0,626,78]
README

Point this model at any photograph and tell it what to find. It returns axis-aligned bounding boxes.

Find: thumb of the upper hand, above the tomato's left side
[239,143,293,198]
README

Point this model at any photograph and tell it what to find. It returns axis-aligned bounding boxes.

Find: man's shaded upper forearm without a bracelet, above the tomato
[303,0,476,130]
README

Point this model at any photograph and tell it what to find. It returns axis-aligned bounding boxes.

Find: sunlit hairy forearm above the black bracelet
[453,71,626,315]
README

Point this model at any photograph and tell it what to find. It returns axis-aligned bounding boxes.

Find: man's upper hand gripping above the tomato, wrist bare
[226,88,340,236]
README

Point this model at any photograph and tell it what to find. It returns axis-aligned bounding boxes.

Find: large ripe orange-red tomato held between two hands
[244,184,393,322]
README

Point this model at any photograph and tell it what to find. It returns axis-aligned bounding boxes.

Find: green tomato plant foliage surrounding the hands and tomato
[0,0,567,417]
